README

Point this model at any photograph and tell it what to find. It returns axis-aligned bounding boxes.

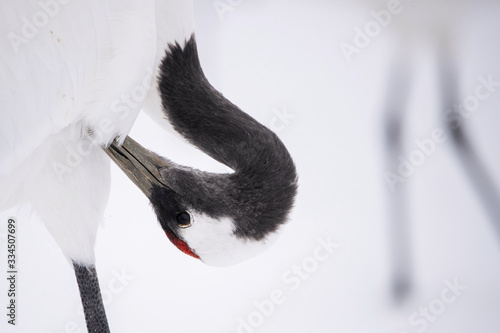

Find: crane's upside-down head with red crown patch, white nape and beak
[105,137,296,266]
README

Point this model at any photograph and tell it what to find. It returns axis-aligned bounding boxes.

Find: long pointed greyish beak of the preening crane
[104,136,172,198]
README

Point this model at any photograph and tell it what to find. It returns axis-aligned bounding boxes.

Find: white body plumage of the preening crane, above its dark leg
[0,0,189,264]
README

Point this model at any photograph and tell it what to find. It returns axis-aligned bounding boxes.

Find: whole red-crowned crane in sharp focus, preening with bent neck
[0,0,297,332]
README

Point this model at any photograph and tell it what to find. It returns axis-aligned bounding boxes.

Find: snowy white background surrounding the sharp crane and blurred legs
[0,0,500,333]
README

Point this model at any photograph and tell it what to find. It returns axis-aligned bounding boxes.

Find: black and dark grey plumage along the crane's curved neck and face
[150,36,297,240]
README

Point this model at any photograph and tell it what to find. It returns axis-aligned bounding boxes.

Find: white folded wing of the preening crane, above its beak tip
[0,0,156,178]
